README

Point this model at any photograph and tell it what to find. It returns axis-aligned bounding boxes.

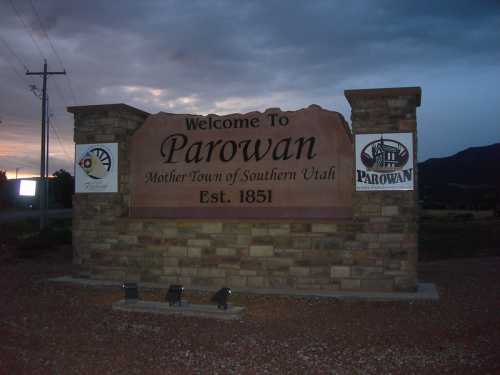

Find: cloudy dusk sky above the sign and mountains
[0,0,500,177]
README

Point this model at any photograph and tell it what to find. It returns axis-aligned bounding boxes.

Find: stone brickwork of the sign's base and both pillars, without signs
[68,88,420,291]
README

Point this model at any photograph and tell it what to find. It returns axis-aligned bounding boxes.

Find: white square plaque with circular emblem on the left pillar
[75,143,118,193]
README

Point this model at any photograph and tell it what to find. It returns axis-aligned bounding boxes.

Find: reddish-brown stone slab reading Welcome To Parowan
[130,106,353,219]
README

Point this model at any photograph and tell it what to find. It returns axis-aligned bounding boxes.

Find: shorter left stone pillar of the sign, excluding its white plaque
[68,104,149,279]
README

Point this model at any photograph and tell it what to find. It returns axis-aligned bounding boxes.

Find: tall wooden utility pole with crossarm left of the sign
[26,59,66,229]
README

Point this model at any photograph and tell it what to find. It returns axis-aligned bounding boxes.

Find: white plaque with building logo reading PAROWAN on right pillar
[356,133,414,191]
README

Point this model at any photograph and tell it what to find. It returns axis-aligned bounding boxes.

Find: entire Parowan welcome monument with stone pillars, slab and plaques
[68,87,421,291]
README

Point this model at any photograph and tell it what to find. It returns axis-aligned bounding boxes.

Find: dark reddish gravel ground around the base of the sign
[0,248,500,374]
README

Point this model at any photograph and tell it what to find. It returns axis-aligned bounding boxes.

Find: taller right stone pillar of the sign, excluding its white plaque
[345,87,421,291]
